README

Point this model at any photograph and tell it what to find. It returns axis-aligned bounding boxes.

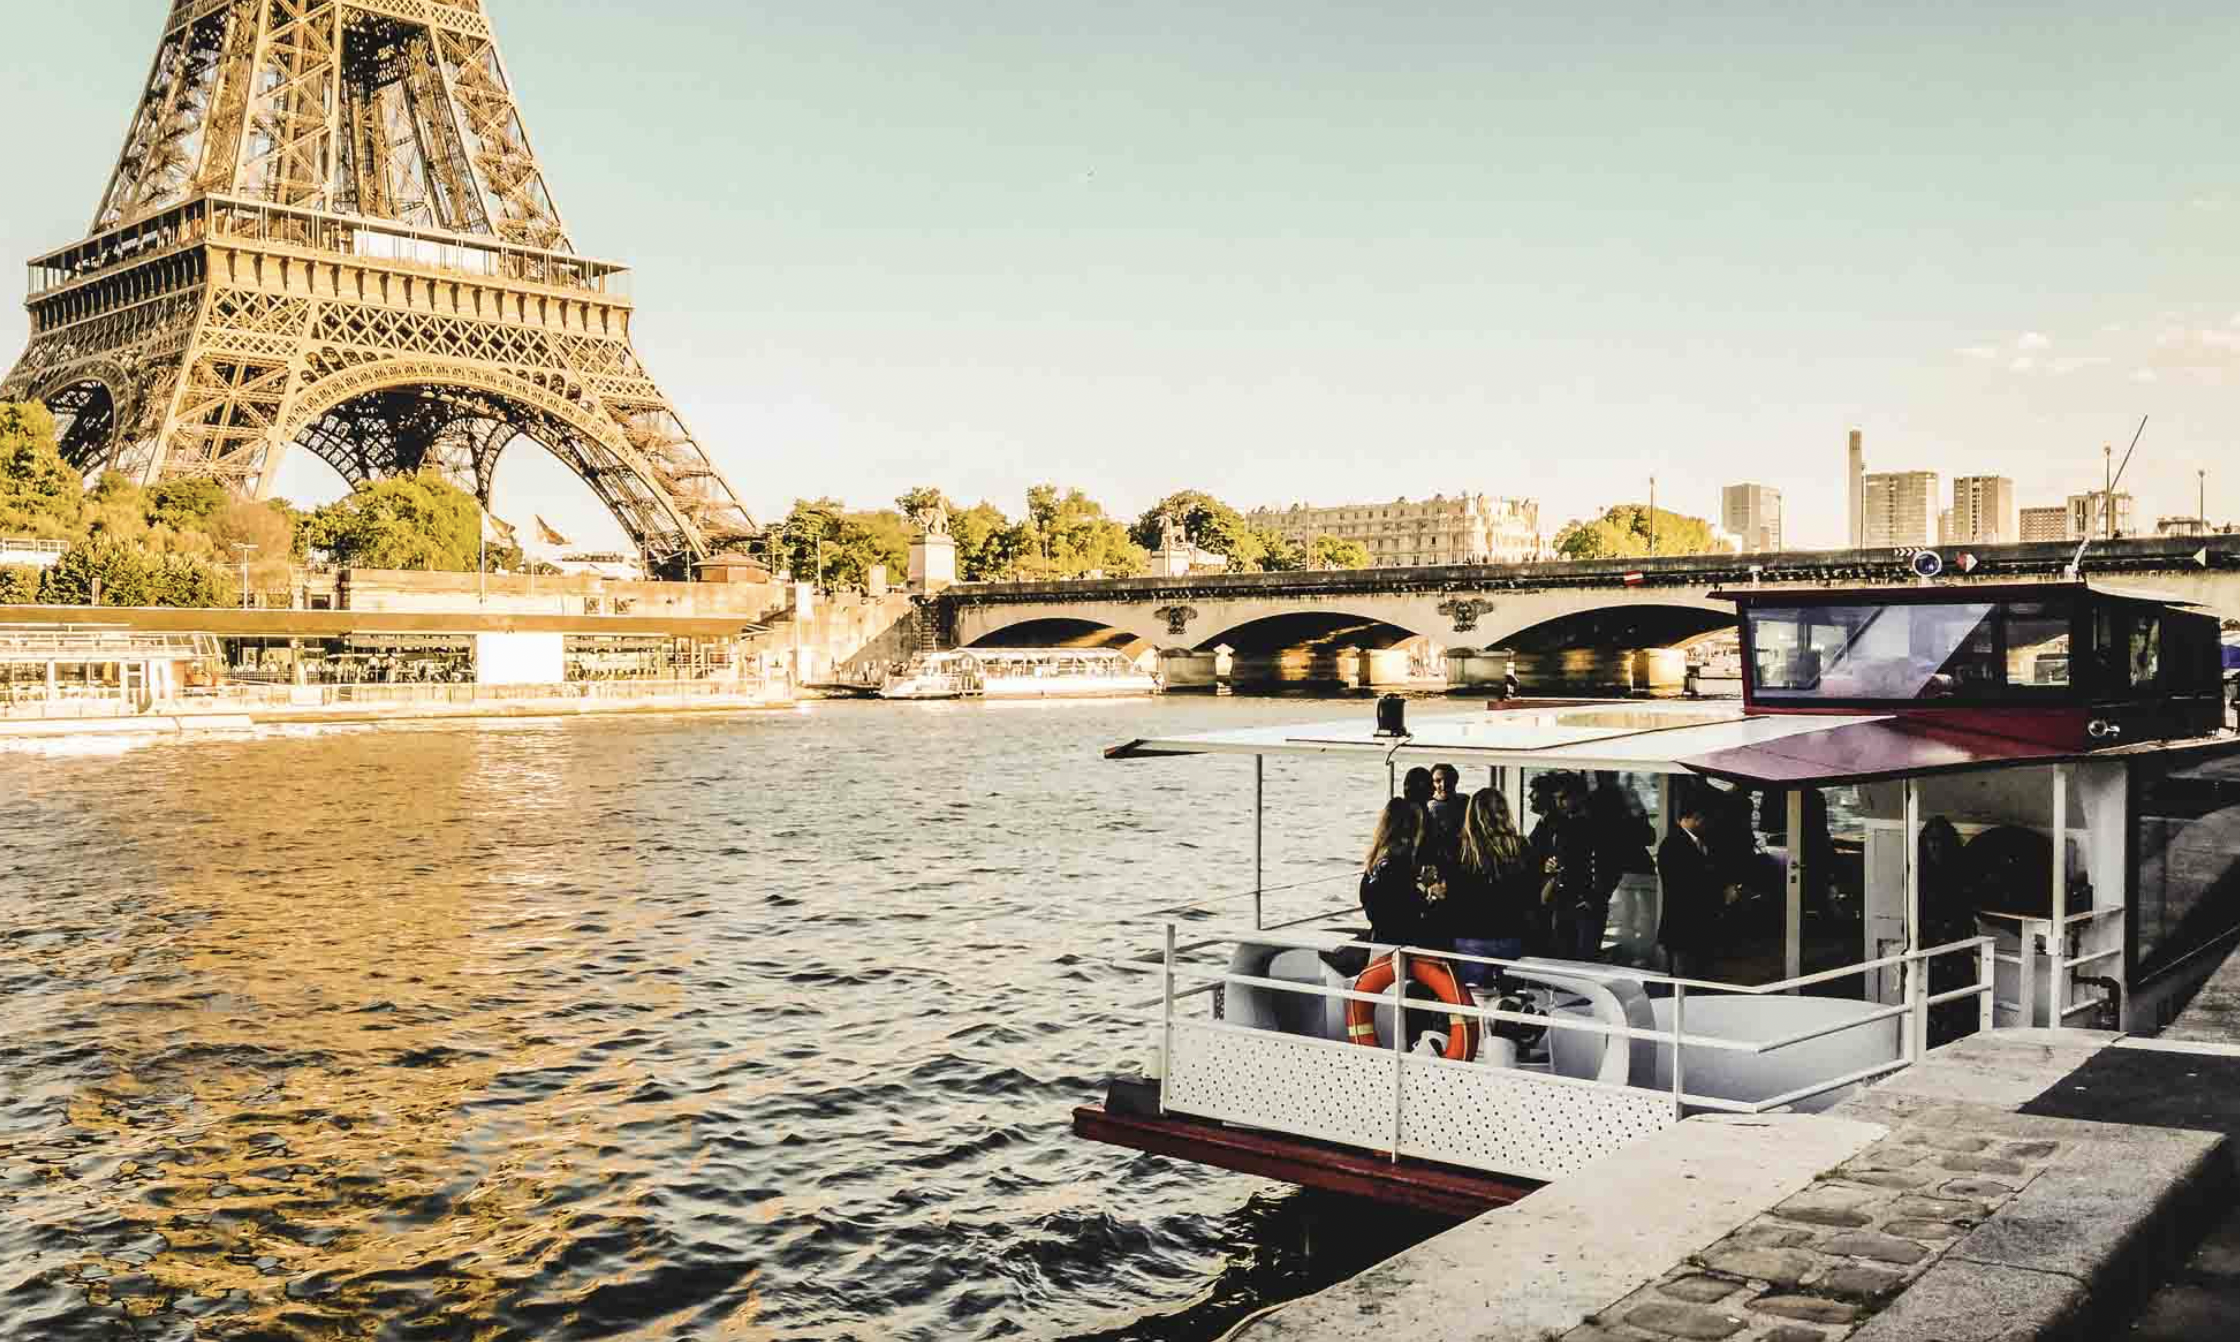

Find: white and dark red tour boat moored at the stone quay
[1075,580,2240,1212]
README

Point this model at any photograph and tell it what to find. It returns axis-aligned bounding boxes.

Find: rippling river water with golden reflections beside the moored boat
[0,699,1434,1342]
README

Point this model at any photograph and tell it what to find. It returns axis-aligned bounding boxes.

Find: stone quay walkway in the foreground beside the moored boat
[1230,954,2240,1342]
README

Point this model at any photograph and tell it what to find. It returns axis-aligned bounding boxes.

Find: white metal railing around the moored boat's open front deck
[1122,914,1994,1161]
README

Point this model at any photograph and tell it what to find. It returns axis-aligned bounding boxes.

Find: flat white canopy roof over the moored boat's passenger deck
[1104,701,1888,773]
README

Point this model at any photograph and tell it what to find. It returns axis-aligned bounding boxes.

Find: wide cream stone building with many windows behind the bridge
[1245,493,1548,569]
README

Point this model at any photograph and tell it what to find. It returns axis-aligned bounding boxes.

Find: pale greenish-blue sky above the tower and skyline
[0,0,2240,544]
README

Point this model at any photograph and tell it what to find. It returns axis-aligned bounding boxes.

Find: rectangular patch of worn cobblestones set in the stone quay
[1564,1125,2063,1342]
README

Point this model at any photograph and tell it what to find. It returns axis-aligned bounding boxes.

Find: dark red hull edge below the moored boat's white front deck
[1073,1105,1541,1217]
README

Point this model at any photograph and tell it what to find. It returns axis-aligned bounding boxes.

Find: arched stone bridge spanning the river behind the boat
[936,535,2240,683]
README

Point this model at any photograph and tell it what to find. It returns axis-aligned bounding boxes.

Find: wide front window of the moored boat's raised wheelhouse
[1745,598,2074,703]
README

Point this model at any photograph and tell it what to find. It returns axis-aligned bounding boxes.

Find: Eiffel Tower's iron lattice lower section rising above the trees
[0,0,755,574]
